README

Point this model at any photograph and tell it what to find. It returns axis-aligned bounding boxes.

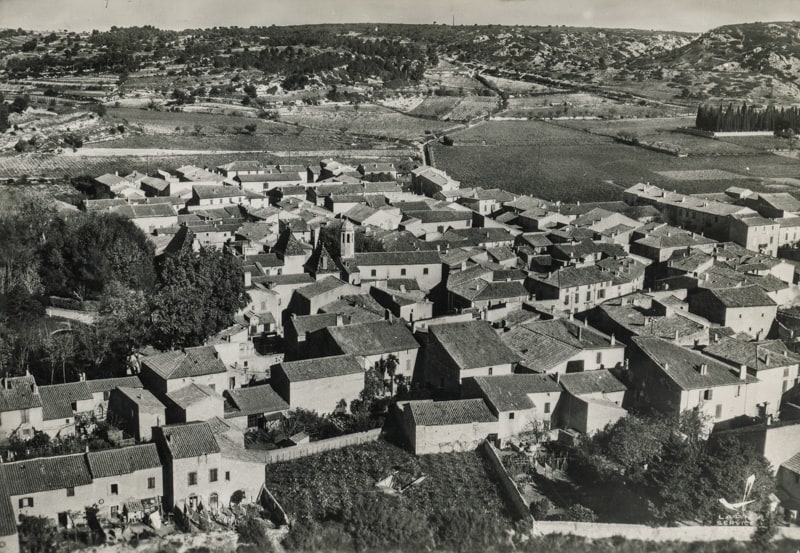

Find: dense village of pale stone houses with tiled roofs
[0,150,800,553]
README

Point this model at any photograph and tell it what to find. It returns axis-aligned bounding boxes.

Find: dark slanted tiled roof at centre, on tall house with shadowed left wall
[428,321,519,370]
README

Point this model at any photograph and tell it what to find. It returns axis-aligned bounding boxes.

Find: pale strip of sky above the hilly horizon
[0,0,800,32]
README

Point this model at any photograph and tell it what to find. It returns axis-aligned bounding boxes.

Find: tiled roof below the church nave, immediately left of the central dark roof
[328,320,419,355]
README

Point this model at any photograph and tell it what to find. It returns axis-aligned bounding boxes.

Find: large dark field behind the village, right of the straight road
[434,121,800,201]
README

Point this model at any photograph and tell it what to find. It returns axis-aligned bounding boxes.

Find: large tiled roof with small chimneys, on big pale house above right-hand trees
[631,336,757,390]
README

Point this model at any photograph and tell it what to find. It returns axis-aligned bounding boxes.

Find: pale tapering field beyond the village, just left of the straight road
[281,105,452,140]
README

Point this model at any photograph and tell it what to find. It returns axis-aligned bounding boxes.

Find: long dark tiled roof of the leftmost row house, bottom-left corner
[0,453,92,496]
